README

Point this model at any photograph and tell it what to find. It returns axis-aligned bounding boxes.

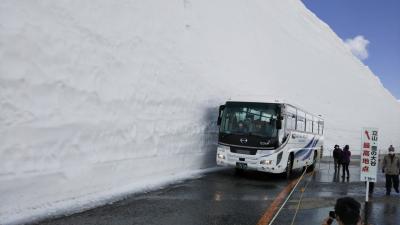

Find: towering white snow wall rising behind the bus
[0,0,400,224]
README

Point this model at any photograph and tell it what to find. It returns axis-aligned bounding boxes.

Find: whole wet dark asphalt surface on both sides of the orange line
[32,160,400,225]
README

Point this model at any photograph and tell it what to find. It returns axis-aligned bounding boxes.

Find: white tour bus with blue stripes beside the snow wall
[216,99,324,177]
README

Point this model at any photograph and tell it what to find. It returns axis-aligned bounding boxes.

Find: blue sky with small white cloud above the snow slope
[303,0,400,99]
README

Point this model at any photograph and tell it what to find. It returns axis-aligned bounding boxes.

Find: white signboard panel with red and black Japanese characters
[360,128,379,182]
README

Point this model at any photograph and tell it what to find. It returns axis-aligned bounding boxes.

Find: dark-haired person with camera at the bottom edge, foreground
[322,197,362,225]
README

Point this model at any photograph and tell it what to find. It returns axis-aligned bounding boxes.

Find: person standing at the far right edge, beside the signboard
[382,145,400,195]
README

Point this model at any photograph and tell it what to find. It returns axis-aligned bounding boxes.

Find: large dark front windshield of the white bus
[220,102,279,138]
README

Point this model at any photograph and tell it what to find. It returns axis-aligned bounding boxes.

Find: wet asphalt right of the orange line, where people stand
[264,159,400,225]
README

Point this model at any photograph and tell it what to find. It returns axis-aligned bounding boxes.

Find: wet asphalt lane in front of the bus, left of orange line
[38,169,301,225]
